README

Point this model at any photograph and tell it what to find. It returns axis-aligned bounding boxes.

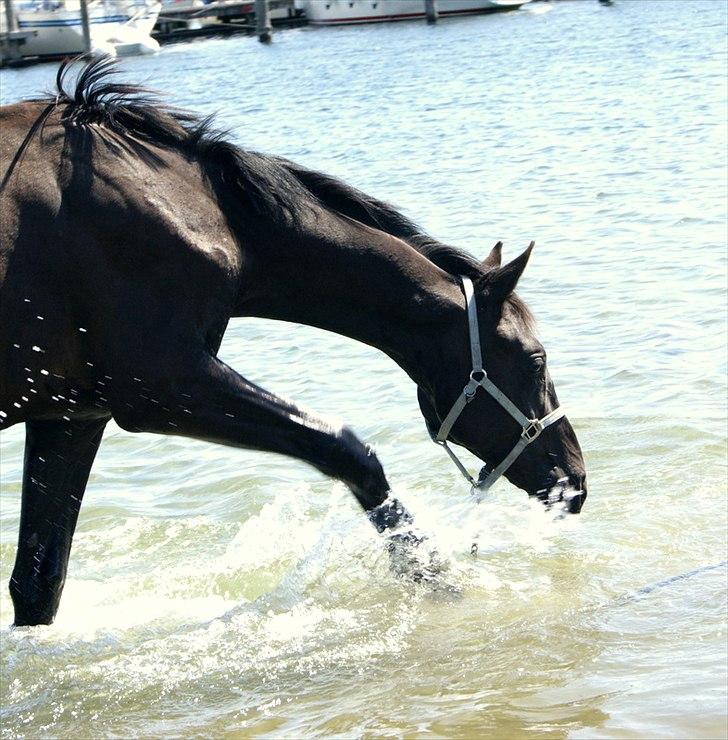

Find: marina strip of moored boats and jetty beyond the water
[0,0,532,62]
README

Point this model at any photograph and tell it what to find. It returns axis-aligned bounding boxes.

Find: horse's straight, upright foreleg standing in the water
[10,419,107,625]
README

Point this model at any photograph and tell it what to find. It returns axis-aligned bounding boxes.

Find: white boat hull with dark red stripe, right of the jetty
[295,0,531,26]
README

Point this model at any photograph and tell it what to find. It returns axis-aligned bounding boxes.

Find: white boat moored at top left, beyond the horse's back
[3,0,162,59]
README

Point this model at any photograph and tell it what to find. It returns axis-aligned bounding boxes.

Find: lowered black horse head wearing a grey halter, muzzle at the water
[418,242,586,513]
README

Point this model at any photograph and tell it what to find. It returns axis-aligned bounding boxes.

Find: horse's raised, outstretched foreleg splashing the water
[112,355,411,531]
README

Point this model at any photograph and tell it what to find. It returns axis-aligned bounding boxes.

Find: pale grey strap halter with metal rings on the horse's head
[430,275,565,501]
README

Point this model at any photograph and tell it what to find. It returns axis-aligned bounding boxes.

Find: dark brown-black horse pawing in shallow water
[0,59,586,625]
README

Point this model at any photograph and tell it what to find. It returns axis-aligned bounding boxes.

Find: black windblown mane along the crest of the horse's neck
[24,56,532,323]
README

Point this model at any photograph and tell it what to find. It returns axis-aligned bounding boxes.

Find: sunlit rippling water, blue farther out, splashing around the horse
[0,0,728,738]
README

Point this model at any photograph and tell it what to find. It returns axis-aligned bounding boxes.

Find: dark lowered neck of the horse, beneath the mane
[235,214,467,387]
